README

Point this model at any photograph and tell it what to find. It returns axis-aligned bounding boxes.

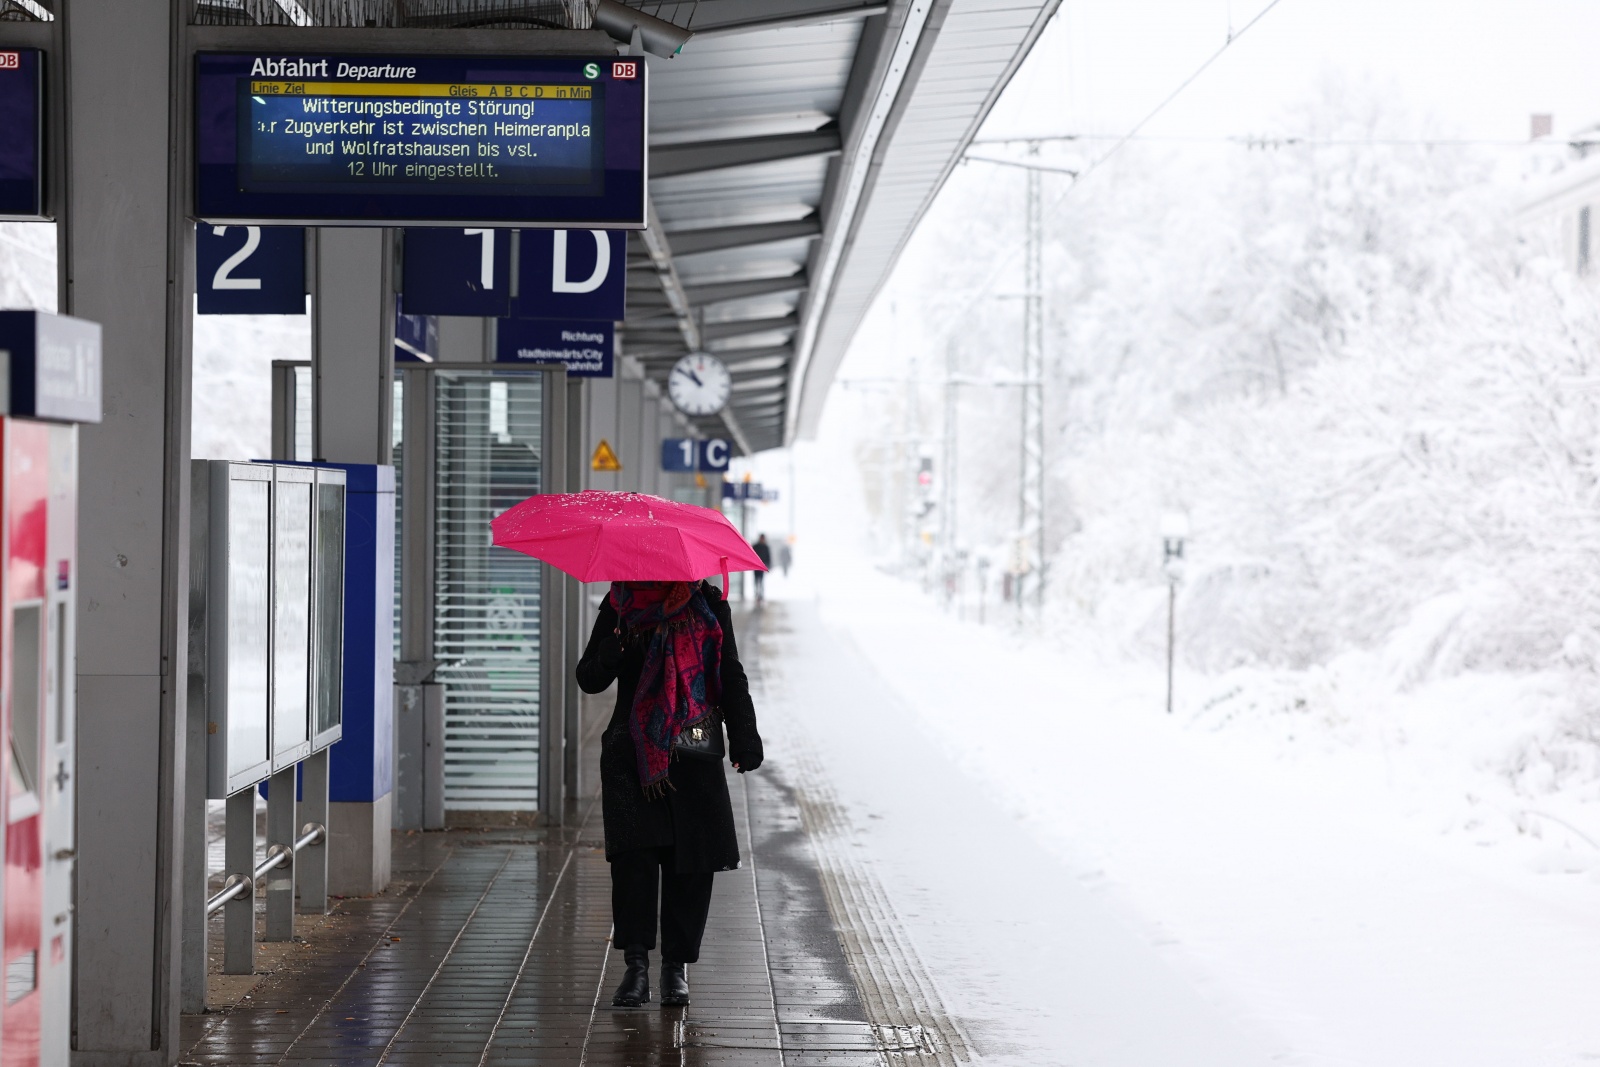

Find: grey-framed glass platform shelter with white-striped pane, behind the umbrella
[274,363,570,824]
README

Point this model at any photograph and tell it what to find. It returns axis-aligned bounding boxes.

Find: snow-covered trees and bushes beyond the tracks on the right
[876,82,1600,686]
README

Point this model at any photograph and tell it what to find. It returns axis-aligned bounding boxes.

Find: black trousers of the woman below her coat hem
[611,846,712,963]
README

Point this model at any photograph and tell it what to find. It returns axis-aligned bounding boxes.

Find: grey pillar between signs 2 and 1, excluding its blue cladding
[307,227,395,896]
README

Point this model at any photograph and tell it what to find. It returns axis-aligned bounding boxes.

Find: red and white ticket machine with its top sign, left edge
[0,312,101,1067]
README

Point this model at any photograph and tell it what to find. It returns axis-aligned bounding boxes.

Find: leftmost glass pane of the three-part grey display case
[227,480,272,777]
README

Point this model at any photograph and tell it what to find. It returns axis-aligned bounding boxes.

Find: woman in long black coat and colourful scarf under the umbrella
[578,582,762,1008]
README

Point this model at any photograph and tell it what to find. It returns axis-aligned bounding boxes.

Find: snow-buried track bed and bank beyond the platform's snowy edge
[790,545,1600,1067]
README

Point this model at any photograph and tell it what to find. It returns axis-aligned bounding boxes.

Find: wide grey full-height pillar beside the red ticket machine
[64,0,194,1067]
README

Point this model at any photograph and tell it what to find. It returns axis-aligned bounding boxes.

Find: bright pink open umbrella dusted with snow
[490,490,766,589]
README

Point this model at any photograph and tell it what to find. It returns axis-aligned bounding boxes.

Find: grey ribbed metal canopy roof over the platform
[159,0,1061,453]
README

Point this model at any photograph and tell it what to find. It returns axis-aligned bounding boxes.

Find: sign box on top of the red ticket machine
[0,312,101,422]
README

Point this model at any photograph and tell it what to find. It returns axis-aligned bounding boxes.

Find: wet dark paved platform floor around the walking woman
[182,604,965,1067]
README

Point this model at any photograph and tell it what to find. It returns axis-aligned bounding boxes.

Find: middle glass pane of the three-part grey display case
[272,482,310,755]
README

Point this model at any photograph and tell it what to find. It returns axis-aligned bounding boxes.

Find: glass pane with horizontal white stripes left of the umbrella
[434,371,544,811]
